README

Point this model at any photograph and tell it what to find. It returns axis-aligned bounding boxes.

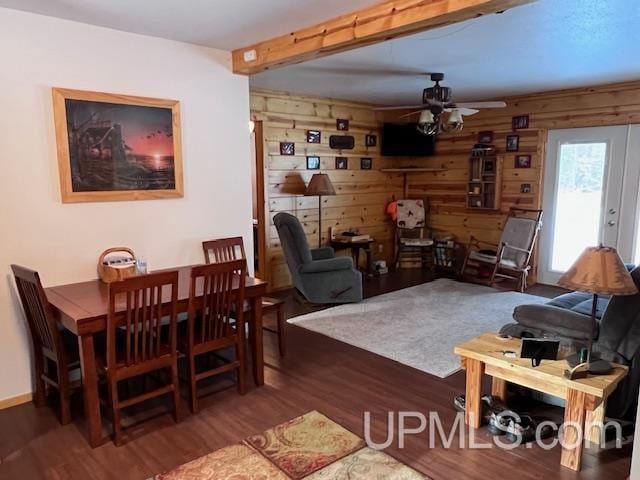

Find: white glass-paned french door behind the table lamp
[539,125,640,284]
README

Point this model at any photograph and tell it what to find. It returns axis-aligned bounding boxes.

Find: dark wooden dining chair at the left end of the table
[11,265,82,425]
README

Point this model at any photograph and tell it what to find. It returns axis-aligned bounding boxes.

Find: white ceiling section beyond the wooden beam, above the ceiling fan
[251,0,640,105]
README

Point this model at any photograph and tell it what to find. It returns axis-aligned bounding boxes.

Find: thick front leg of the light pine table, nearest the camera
[560,388,586,472]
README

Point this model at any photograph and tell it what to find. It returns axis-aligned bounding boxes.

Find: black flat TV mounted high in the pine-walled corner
[382,123,436,157]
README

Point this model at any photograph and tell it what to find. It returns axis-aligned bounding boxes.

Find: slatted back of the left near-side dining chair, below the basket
[107,272,178,368]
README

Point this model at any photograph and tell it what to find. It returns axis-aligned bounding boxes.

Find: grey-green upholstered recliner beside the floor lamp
[273,212,362,303]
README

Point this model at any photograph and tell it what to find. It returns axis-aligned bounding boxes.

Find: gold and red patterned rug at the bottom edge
[153,411,429,480]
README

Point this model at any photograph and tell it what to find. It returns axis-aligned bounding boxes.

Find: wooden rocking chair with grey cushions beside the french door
[460,208,542,292]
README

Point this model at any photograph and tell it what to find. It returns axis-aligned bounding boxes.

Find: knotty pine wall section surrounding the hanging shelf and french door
[387,82,640,280]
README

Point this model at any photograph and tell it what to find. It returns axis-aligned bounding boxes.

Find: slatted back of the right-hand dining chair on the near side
[189,260,247,345]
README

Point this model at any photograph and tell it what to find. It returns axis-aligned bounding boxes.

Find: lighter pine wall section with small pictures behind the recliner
[251,90,402,289]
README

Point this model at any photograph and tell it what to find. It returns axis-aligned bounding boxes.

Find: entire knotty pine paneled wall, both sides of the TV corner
[251,82,640,288]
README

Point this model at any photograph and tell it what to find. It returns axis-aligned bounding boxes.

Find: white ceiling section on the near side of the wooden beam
[0,0,380,50]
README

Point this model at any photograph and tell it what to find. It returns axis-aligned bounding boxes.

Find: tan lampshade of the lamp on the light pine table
[558,246,638,295]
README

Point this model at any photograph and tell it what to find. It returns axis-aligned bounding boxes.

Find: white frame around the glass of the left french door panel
[538,125,637,285]
